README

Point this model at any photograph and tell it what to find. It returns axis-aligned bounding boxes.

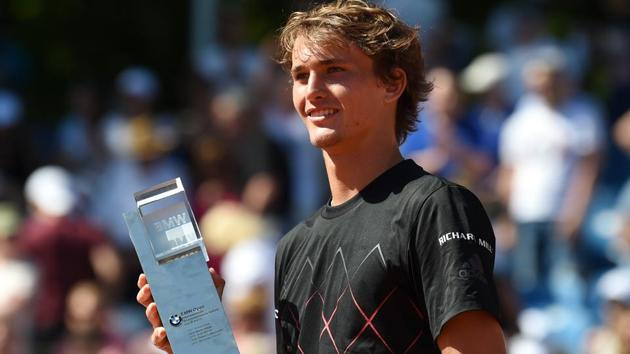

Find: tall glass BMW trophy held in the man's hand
[123,178,239,354]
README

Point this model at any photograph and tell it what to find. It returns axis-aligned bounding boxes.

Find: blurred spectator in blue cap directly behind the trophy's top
[91,67,189,250]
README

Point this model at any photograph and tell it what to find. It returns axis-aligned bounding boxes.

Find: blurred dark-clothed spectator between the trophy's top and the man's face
[193,87,283,221]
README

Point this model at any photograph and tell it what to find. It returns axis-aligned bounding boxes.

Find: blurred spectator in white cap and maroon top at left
[16,166,120,354]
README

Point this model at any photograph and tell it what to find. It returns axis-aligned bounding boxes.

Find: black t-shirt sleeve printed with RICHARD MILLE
[412,185,498,338]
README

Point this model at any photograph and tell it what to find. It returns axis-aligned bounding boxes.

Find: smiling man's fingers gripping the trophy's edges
[136,268,225,354]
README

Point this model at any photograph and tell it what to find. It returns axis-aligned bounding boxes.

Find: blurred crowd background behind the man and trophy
[0,0,630,354]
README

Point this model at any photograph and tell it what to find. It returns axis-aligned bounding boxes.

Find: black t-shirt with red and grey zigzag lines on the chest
[275,160,498,354]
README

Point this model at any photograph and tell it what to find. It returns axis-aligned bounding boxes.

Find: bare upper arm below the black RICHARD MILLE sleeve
[437,311,507,354]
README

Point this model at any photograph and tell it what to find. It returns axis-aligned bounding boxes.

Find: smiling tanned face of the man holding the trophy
[291,37,395,153]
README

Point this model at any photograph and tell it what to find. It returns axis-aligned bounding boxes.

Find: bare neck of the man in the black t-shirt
[324,146,403,206]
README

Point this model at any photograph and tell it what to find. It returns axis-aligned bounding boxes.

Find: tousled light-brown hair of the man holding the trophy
[278,0,433,143]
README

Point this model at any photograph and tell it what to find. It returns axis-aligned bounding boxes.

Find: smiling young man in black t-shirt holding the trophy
[138,0,505,354]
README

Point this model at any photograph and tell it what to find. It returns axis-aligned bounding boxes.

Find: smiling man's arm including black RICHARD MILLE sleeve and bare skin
[414,184,506,354]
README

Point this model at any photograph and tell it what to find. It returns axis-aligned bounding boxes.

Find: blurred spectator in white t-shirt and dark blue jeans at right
[498,46,601,332]
